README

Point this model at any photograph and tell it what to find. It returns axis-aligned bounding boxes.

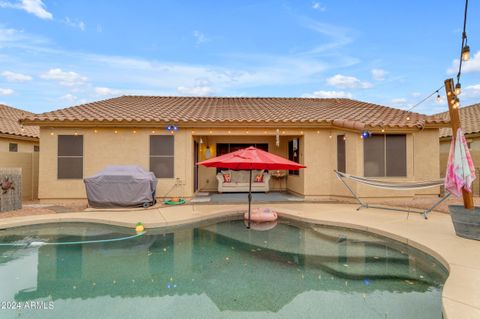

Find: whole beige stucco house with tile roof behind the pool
[21,96,448,200]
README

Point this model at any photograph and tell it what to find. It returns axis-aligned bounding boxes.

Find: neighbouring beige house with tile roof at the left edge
[0,104,40,200]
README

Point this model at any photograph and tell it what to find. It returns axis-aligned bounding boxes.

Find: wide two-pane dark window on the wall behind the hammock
[363,134,407,177]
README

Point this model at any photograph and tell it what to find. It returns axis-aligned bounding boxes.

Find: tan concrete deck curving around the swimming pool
[0,202,480,319]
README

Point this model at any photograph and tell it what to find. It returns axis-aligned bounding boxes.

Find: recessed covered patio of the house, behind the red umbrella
[192,128,303,195]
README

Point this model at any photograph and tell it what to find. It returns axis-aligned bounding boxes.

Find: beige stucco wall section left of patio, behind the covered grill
[39,128,193,199]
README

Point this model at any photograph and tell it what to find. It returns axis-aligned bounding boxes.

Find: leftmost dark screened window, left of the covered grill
[57,135,83,179]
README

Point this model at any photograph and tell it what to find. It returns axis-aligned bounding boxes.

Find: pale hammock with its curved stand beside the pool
[334,170,450,219]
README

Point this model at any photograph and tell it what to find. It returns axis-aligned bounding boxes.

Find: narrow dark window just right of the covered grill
[150,135,175,178]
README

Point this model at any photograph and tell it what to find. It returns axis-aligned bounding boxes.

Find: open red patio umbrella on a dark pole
[197,146,306,228]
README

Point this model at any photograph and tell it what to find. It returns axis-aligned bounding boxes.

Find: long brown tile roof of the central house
[20,96,447,129]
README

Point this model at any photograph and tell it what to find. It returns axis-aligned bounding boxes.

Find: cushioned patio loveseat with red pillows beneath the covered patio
[217,170,270,193]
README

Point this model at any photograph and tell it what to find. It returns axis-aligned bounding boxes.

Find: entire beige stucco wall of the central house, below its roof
[39,127,439,199]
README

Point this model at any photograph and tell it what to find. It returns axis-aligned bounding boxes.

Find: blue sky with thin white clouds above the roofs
[0,0,480,114]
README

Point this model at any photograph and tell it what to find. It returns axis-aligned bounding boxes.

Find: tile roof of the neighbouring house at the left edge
[0,104,39,138]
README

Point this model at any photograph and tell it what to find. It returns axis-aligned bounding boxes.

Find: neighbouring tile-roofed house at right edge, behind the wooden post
[437,103,480,196]
